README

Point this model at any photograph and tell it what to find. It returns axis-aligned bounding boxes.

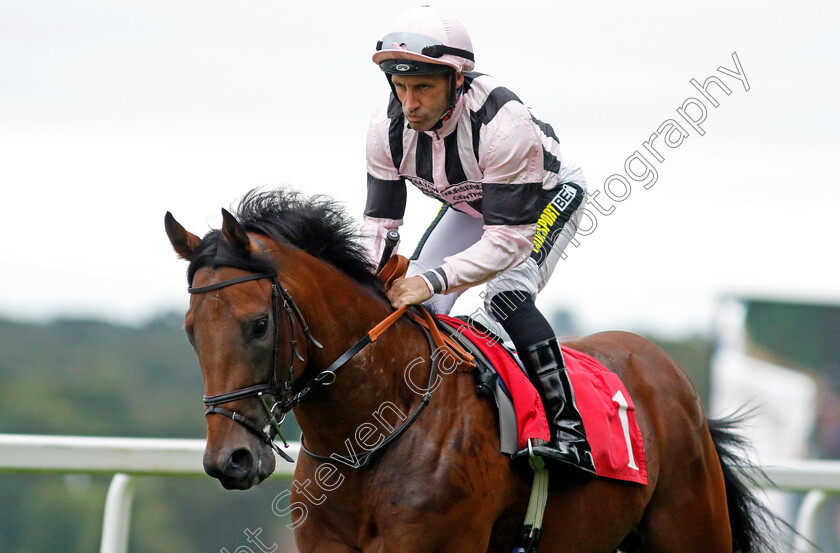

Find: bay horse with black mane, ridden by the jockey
[165,189,772,553]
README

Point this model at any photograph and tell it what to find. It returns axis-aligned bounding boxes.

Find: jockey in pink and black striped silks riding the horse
[362,6,595,474]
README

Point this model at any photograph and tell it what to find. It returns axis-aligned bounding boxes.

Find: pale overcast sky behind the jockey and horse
[0,0,840,333]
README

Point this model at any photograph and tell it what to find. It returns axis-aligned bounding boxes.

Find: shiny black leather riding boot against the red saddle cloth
[511,338,595,474]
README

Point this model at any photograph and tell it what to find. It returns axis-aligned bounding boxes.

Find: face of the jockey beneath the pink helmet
[391,73,464,131]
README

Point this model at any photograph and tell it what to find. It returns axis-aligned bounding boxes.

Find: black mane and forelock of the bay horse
[187,188,377,286]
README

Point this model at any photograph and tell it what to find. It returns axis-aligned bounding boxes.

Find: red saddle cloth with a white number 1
[437,315,647,484]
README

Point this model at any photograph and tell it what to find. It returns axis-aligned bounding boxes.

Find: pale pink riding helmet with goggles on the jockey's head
[373,5,475,74]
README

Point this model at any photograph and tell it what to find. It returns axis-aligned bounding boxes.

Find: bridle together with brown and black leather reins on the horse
[187,255,474,467]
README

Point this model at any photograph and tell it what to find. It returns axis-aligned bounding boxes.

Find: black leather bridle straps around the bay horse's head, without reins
[187,272,324,462]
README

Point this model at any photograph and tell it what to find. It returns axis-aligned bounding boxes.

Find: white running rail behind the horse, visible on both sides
[0,434,840,553]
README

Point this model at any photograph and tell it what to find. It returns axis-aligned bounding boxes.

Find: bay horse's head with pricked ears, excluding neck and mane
[165,210,296,489]
